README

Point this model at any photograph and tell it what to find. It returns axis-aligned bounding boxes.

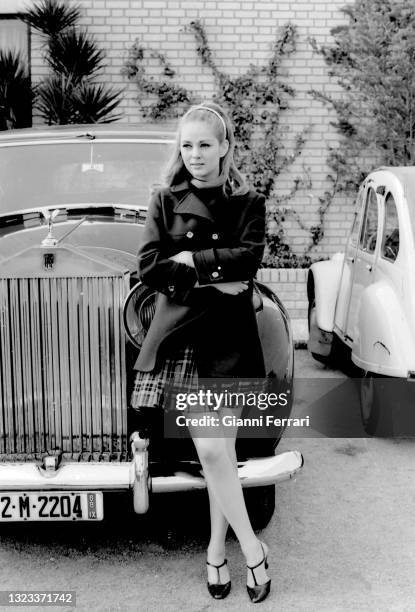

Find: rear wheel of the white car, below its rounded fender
[360,372,392,436]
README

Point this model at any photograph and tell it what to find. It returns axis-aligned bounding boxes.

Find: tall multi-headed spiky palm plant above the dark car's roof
[25,0,122,125]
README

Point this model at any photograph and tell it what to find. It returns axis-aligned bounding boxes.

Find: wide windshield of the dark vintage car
[0,141,172,213]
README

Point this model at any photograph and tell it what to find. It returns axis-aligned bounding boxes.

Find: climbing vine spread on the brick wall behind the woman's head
[123,20,324,267]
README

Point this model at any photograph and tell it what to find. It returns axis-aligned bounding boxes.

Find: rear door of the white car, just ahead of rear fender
[346,183,379,342]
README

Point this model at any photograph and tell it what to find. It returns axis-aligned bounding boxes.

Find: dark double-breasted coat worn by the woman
[135,182,265,378]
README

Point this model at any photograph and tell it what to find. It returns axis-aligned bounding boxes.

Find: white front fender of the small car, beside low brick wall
[307,253,344,332]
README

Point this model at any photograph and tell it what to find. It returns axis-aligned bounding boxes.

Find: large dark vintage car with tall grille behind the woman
[0,124,302,527]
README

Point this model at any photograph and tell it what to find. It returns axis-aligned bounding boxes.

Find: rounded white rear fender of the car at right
[352,281,415,378]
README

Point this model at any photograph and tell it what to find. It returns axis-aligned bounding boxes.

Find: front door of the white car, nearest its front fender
[334,184,366,334]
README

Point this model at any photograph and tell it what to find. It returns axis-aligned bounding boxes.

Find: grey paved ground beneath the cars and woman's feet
[0,351,415,612]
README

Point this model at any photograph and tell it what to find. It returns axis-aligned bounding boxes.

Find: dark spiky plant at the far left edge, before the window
[0,50,34,130]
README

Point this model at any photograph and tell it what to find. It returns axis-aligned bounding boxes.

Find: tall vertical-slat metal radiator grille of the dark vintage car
[0,274,129,461]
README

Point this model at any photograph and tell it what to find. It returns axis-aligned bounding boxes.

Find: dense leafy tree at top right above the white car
[310,0,415,232]
